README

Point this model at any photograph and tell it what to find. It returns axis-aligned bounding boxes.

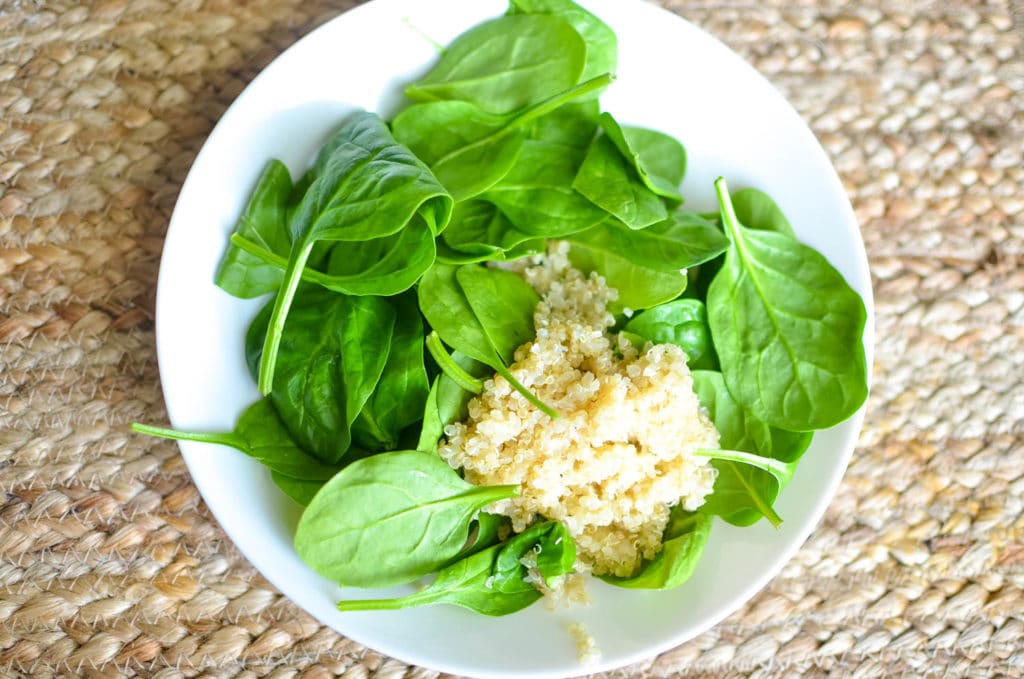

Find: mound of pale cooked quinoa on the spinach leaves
[439,244,719,577]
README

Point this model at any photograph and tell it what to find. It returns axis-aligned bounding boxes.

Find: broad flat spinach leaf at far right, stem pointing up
[708,178,867,431]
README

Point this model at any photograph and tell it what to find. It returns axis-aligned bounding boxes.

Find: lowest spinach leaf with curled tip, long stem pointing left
[338,523,575,616]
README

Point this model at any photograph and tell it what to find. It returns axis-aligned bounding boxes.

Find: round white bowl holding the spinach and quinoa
[157,0,873,677]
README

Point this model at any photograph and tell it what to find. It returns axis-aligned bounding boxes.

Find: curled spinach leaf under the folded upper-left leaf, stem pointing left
[231,217,435,295]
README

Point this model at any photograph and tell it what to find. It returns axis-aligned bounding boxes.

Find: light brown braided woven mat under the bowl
[0,0,1024,679]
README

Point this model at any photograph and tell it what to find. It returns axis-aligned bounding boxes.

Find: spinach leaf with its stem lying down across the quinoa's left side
[417,263,558,418]
